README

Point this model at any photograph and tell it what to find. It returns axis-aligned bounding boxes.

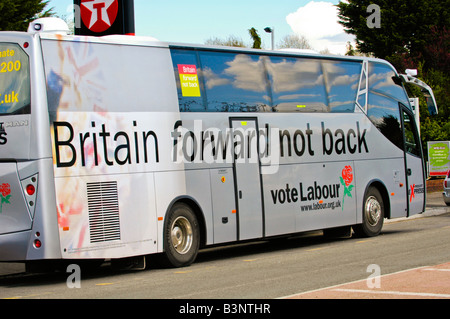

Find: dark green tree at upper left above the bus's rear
[0,0,54,31]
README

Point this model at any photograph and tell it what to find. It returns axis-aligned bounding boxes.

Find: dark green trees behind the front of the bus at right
[337,0,450,154]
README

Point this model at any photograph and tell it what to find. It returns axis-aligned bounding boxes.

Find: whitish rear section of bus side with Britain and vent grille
[42,35,185,258]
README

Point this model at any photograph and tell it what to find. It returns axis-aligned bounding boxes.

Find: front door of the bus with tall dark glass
[402,107,426,216]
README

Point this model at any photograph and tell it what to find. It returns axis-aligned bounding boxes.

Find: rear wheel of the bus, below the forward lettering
[163,203,200,267]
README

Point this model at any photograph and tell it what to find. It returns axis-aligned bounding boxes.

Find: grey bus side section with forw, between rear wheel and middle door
[173,112,239,244]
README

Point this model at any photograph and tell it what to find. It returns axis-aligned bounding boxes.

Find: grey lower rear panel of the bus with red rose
[0,162,31,235]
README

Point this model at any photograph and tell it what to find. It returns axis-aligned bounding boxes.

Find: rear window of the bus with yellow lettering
[0,43,30,115]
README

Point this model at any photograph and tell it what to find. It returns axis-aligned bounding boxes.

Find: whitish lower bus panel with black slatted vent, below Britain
[56,173,157,259]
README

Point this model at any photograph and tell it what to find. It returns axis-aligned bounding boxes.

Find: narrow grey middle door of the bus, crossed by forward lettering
[230,118,264,240]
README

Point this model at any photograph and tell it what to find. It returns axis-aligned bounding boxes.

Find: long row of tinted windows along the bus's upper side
[171,48,409,154]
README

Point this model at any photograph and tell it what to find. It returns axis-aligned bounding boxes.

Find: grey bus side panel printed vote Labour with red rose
[264,161,356,236]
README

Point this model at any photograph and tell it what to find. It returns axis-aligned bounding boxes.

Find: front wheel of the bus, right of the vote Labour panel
[353,186,384,237]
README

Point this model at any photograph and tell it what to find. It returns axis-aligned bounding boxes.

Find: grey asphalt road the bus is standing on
[0,194,450,299]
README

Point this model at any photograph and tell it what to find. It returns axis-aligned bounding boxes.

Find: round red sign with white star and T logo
[80,0,119,33]
